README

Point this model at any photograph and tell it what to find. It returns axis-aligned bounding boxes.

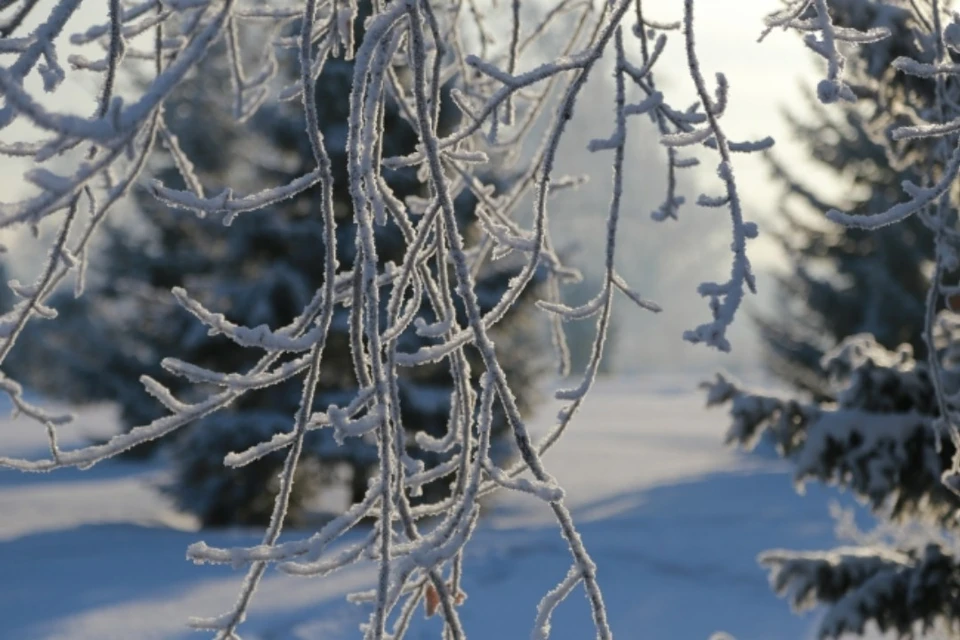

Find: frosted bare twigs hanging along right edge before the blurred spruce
[792,0,960,483]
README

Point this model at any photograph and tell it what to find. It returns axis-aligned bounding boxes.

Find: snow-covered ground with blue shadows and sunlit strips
[0,377,864,640]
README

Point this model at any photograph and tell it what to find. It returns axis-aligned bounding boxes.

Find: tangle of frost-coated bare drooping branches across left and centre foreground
[0,0,804,640]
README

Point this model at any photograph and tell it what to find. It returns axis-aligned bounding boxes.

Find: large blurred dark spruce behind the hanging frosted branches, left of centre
[14,19,541,526]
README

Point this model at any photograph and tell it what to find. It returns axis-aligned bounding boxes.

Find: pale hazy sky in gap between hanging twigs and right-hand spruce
[552,0,844,370]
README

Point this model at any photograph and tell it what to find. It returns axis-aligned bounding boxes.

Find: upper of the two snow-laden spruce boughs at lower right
[703,336,960,526]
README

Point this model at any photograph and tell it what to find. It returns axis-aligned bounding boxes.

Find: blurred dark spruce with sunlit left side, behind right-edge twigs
[755,2,933,399]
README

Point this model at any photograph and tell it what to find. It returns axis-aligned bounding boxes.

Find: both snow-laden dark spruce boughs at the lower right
[704,330,960,638]
